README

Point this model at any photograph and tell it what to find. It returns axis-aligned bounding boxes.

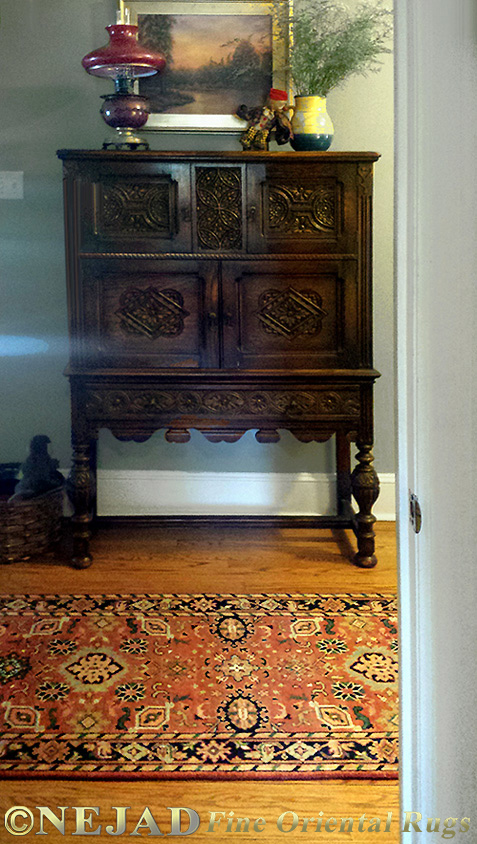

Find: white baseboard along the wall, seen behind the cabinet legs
[94,469,395,521]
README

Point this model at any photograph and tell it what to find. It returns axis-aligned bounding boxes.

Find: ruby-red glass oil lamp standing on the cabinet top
[82,23,166,149]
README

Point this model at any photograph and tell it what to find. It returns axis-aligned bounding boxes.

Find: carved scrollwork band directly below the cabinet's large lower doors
[86,389,360,419]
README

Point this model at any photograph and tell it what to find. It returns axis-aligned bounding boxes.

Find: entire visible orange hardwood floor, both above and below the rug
[0,523,399,844]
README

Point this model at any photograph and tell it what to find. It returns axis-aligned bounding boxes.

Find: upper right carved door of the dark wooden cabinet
[247,161,357,254]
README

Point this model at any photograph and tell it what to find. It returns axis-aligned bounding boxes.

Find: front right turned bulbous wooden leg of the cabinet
[351,442,379,569]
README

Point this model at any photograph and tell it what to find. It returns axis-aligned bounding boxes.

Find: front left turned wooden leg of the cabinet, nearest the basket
[66,442,96,569]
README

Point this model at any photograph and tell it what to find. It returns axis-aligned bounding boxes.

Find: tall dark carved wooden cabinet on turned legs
[58,150,379,568]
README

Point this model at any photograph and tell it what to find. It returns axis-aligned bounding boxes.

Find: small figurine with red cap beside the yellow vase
[236,88,293,150]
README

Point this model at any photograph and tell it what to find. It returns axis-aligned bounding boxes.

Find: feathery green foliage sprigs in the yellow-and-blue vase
[273,0,392,97]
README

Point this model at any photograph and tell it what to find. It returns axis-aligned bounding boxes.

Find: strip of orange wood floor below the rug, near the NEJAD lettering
[0,780,399,844]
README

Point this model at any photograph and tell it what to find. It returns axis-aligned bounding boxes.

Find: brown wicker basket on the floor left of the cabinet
[0,487,63,563]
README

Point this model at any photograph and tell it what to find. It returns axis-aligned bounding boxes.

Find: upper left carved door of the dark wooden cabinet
[79,164,192,253]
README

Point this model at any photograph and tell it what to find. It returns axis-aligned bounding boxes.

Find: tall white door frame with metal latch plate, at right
[395,0,477,832]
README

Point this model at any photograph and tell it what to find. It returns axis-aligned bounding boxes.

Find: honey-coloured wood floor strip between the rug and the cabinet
[0,522,396,594]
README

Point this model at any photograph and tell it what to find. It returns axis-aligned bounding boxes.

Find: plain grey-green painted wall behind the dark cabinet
[0,0,394,482]
